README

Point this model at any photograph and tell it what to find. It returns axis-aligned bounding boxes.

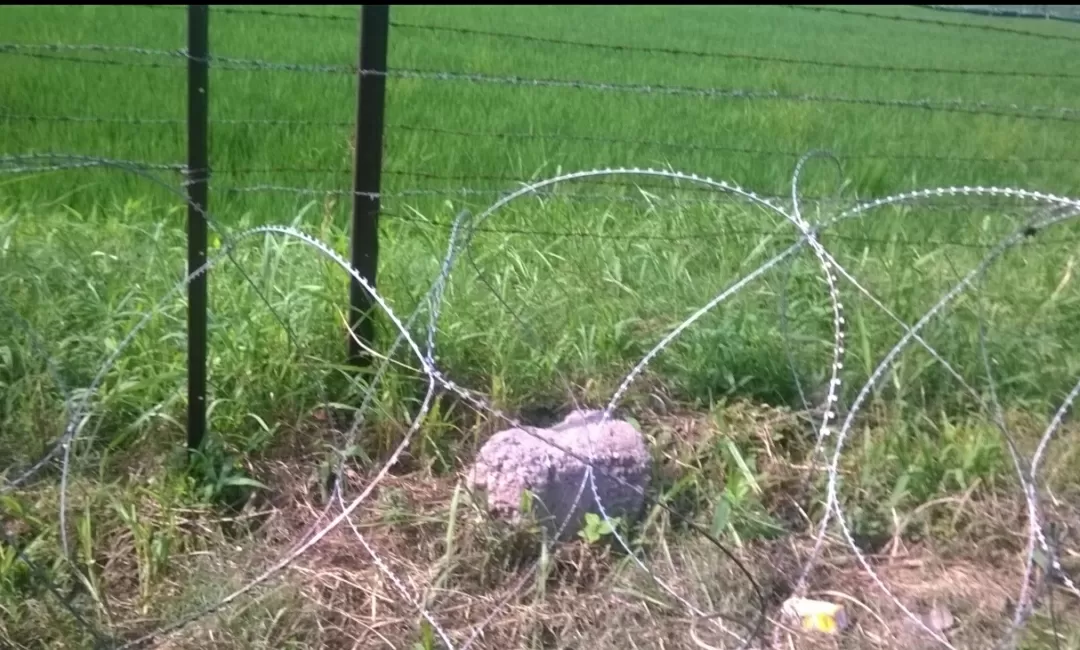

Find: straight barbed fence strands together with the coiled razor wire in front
[0,5,1080,648]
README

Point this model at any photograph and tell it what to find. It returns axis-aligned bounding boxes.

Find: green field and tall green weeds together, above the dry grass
[0,6,1080,459]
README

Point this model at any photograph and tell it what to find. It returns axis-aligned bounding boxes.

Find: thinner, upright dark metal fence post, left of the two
[187,4,210,450]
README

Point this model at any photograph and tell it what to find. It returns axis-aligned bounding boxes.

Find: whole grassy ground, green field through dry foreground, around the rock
[0,6,1080,649]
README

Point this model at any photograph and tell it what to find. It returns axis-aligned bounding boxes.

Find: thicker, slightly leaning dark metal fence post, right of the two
[349,4,390,365]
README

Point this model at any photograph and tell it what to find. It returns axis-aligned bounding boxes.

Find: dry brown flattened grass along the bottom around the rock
[0,405,1080,650]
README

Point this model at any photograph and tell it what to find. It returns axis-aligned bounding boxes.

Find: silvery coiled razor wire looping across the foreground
[0,152,1080,650]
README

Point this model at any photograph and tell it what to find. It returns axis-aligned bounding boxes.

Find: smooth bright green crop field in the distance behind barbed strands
[0,6,1080,212]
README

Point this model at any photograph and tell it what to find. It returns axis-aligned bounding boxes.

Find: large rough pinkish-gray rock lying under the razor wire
[469,410,651,540]
